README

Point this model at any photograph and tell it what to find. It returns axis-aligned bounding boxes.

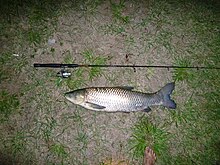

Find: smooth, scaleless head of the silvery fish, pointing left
[64,89,85,104]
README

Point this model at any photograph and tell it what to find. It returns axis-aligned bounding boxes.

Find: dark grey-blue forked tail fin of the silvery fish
[158,82,176,109]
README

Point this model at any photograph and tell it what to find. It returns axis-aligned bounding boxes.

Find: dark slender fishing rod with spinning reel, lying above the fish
[34,63,220,78]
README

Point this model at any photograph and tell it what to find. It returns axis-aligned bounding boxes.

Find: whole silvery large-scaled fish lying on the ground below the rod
[64,82,176,112]
